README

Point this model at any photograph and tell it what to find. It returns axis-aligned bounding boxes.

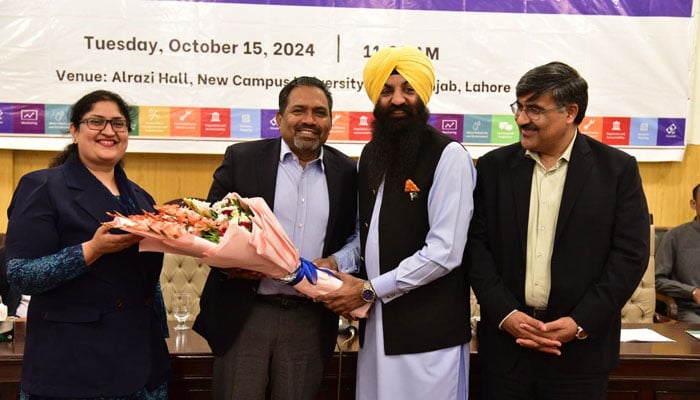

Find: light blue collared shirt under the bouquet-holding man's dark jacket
[258,140,329,294]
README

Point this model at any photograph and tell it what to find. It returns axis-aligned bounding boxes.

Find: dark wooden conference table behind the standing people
[0,323,700,400]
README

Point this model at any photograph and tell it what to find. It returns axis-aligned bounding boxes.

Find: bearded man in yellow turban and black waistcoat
[321,47,476,400]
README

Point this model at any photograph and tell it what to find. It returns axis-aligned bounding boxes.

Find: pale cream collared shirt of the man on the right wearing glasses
[525,134,576,308]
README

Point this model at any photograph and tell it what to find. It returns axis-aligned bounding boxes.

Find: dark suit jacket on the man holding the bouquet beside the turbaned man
[194,138,357,356]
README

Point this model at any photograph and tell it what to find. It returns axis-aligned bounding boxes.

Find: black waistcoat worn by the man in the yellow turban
[358,127,471,355]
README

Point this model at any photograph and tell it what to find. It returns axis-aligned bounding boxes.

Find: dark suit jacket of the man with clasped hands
[466,134,649,373]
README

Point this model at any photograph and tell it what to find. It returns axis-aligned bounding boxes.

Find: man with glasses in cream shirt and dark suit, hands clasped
[465,62,649,400]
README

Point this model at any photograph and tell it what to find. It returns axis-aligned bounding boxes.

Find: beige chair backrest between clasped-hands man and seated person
[622,224,656,323]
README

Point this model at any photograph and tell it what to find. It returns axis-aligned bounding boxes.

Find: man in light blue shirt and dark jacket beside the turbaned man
[194,76,359,400]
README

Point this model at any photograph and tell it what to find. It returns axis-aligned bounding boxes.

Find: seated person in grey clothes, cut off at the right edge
[655,185,700,323]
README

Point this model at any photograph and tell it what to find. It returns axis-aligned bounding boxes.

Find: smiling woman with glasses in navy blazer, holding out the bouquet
[6,90,170,400]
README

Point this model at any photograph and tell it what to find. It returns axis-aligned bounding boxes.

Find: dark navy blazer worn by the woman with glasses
[6,156,169,397]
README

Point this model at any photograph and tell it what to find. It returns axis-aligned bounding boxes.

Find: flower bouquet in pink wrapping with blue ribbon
[107,193,370,318]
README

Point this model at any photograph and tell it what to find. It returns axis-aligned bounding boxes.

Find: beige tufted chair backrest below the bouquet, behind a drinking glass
[160,253,209,321]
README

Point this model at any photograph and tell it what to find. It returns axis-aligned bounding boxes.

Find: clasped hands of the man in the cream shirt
[502,311,564,356]
